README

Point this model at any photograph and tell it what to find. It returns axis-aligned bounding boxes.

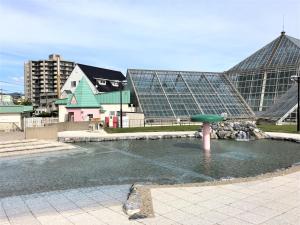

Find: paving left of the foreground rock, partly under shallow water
[0,185,140,225]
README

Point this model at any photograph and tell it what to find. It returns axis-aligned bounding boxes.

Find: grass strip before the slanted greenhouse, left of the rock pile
[104,125,200,133]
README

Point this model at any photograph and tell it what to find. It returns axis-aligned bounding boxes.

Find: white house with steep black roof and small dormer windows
[61,64,126,94]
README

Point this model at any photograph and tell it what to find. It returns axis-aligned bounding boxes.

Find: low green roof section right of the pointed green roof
[96,90,130,105]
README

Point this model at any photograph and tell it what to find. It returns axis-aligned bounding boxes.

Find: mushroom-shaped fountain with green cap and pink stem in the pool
[191,114,224,151]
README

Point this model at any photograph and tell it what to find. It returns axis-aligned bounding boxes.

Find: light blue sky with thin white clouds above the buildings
[0,0,300,92]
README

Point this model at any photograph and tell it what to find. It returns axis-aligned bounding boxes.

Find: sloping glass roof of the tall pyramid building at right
[228,32,300,72]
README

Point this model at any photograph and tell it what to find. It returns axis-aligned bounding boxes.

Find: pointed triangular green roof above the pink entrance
[66,77,100,108]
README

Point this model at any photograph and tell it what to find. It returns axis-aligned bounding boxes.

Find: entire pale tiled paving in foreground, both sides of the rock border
[0,171,300,225]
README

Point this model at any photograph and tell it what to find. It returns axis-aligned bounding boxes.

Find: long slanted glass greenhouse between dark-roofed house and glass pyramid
[127,69,255,120]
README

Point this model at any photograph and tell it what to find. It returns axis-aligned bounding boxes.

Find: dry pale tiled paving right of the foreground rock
[141,172,300,225]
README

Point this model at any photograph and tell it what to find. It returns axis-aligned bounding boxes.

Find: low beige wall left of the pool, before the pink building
[25,121,90,139]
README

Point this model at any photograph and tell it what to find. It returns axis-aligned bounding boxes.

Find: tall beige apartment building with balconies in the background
[24,54,75,111]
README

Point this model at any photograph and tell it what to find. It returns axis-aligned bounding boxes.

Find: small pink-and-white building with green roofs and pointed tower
[55,77,137,126]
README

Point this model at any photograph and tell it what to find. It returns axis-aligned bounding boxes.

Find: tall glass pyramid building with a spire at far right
[226,32,300,112]
